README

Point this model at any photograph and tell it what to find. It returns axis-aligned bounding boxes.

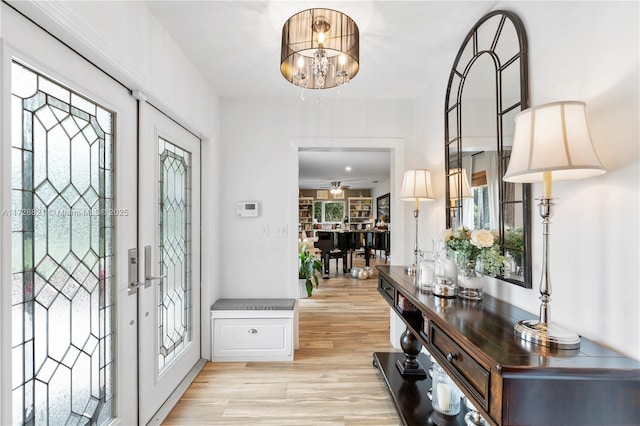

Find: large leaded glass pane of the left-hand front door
[10,62,115,425]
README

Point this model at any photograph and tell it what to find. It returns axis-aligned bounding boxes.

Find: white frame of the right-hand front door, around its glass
[137,100,204,424]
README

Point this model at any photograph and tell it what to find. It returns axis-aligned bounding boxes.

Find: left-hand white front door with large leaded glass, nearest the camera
[0,5,137,425]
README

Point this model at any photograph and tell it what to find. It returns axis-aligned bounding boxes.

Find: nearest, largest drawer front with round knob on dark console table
[429,322,490,409]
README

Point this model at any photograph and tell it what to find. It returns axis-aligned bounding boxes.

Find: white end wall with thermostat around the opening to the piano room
[215,98,415,297]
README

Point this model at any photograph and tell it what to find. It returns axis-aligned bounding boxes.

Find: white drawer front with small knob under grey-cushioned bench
[213,318,292,357]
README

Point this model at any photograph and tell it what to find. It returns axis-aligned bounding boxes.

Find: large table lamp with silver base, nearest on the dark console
[503,101,605,349]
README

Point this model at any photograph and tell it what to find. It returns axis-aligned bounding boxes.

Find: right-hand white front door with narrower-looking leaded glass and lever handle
[139,104,200,423]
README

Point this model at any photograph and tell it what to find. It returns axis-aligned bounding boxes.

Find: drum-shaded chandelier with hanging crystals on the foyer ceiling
[280,9,360,89]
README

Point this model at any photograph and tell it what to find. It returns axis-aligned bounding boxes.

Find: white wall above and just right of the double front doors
[1,1,220,358]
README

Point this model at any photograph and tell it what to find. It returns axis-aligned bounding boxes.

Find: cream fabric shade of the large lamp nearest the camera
[503,101,605,183]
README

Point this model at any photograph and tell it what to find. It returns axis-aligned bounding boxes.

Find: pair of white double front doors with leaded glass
[0,4,200,425]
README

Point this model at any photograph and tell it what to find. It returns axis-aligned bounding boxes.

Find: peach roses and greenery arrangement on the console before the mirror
[442,227,505,277]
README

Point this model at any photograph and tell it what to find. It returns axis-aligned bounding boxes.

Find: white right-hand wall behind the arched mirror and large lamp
[416,2,640,359]
